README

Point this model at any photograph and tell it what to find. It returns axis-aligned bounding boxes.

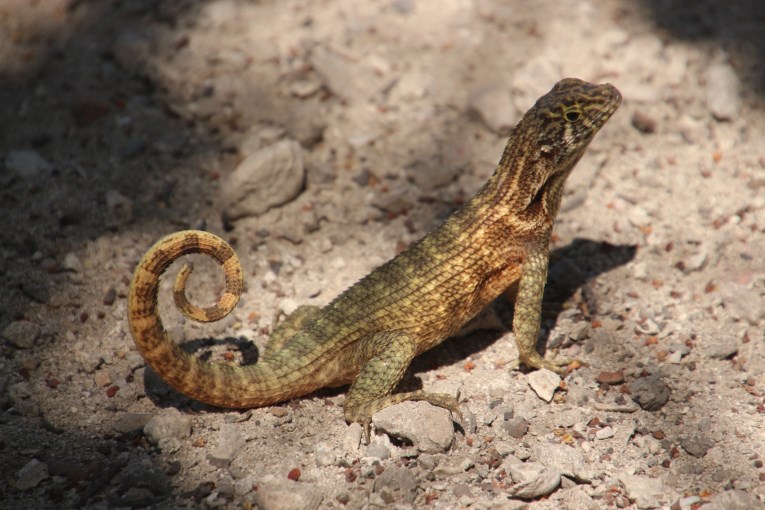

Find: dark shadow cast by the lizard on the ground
[144,238,637,412]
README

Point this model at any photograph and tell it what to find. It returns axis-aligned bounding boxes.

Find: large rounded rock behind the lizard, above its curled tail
[221,140,305,220]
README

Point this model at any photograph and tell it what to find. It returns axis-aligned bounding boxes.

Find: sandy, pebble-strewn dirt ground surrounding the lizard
[0,0,765,509]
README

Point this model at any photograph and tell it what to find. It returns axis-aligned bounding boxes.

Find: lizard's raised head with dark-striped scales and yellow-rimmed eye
[532,78,622,173]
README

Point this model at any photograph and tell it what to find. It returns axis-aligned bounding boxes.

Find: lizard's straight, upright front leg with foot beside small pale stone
[513,239,572,373]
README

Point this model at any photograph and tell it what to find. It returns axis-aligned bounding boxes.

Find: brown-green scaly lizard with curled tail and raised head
[128,78,621,441]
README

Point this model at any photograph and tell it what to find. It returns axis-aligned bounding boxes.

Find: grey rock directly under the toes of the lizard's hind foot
[372,401,454,453]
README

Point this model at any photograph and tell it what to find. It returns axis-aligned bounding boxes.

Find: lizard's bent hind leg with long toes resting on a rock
[345,331,462,444]
